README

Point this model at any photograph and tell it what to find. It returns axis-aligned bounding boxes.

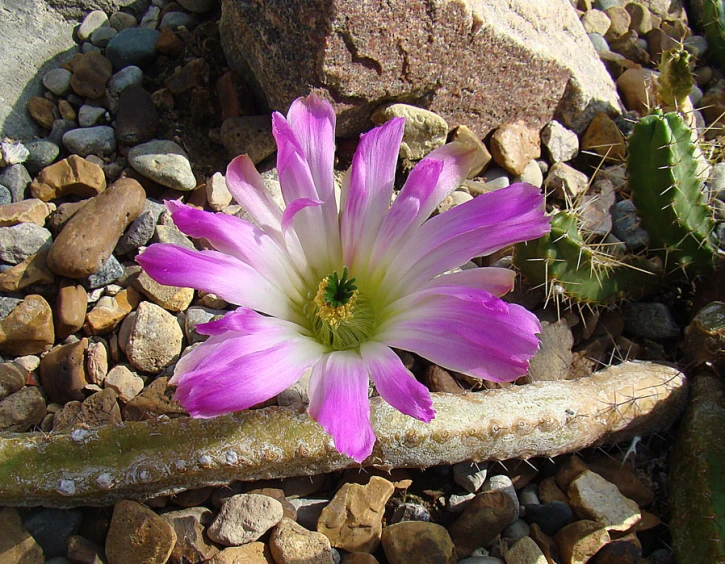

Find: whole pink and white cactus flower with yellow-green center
[138,95,549,462]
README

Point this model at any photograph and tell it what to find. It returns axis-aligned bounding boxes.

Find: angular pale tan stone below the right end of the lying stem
[566,470,642,532]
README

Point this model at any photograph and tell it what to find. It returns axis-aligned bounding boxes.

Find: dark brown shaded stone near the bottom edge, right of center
[448,490,517,558]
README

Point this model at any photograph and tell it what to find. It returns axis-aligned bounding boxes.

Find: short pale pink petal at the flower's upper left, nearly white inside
[226,155,282,235]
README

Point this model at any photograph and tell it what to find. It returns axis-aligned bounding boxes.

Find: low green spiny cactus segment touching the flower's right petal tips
[514,211,658,305]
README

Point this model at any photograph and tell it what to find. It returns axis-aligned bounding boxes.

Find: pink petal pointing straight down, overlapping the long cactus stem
[309,351,375,462]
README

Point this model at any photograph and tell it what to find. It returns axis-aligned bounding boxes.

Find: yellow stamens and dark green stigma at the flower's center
[305,267,375,350]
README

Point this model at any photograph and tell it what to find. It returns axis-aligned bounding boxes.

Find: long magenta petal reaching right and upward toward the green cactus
[383,183,550,289]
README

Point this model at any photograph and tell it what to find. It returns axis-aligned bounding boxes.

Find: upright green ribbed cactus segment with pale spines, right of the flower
[627,110,717,274]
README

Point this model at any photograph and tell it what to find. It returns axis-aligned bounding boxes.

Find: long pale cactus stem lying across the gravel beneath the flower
[0,362,686,507]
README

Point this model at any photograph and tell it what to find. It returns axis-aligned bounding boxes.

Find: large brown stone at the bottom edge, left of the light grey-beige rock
[106,500,176,564]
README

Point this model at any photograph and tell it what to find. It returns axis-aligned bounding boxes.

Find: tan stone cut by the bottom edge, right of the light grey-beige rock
[269,517,334,564]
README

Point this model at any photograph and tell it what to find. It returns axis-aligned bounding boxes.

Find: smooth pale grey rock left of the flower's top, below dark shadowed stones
[128,139,196,192]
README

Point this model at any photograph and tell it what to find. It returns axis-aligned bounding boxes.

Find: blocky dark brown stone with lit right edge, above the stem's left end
[40,339,88,403]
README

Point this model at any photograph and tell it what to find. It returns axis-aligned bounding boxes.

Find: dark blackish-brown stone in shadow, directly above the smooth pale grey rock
[116,85,159,145]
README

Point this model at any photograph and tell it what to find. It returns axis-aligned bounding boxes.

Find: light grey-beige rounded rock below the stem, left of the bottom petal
[207,494,283,546]
